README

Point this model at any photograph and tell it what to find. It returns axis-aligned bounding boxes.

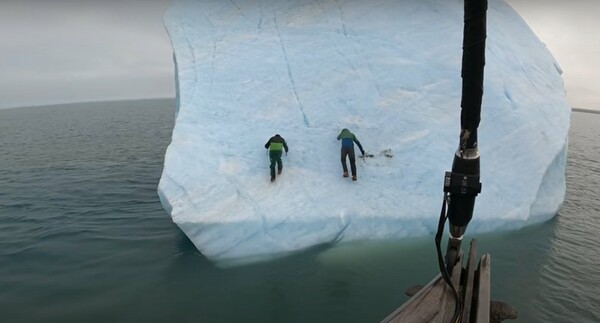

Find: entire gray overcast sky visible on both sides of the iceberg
[0,0,600,110]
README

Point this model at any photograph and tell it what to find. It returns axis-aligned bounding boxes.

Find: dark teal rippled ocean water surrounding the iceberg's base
[0,100,600,323]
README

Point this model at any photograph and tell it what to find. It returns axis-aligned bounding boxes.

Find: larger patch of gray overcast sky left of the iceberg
[0,0,175,108]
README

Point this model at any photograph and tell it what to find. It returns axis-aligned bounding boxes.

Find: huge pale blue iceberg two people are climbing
[158,0,570,264]
